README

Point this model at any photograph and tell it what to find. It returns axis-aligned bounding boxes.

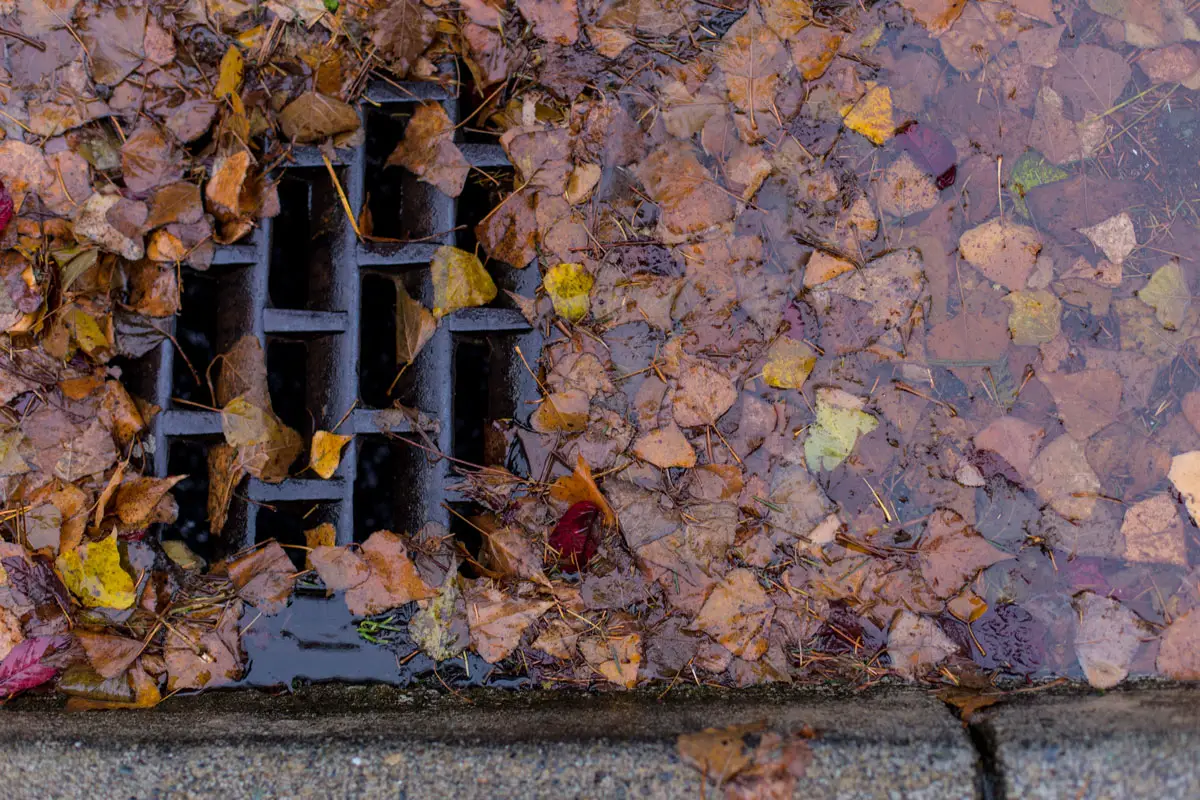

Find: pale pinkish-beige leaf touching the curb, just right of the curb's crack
[1072,591,1146,688]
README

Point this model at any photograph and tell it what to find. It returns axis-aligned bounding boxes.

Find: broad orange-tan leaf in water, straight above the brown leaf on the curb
[692,570,775,661]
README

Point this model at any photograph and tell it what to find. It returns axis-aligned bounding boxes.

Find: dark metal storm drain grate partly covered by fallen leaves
[139,84,540,551]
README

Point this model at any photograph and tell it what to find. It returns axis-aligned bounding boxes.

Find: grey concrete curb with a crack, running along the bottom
[0,686,1200,800]
